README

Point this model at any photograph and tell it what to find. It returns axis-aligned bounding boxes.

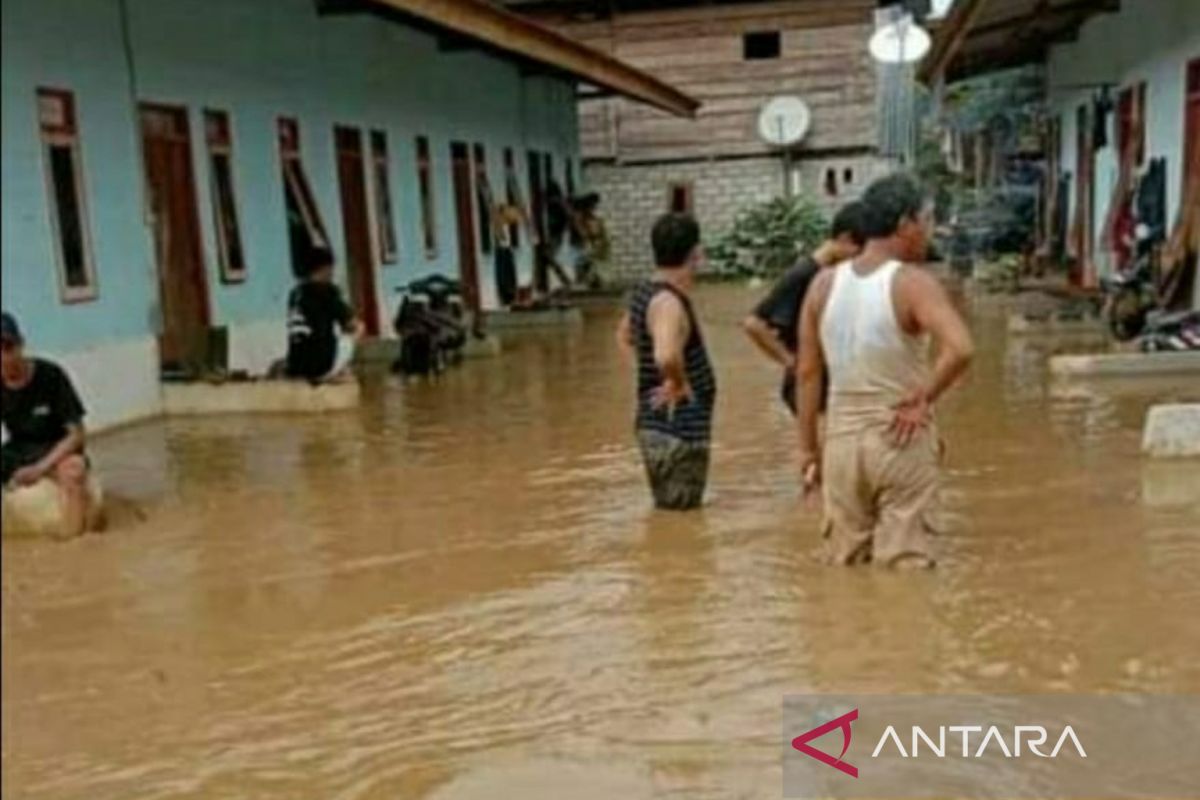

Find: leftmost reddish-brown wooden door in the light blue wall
[139,104,209,373]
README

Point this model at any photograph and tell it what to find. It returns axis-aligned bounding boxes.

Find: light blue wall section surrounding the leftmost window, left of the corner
[0,0,157,350]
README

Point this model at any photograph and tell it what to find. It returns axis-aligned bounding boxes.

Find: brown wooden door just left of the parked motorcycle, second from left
[334,126,379,336]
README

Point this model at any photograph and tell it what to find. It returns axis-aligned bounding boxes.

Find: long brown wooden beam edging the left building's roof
[368,0,700,116]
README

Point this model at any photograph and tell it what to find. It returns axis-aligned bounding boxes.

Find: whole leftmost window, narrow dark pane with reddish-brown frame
[37,89,96,302]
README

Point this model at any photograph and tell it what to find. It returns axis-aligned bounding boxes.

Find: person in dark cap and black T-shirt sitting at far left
[0,312,90,539]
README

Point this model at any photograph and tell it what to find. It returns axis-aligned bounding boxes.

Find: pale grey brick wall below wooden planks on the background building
[586,155,886,284]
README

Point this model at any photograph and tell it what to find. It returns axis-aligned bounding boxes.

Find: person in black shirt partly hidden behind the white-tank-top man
[742,201,866,414]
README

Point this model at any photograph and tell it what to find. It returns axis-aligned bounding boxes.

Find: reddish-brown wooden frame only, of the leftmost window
[35,86,100,305]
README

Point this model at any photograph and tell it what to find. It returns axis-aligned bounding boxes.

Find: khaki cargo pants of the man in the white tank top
[822,426,940,567]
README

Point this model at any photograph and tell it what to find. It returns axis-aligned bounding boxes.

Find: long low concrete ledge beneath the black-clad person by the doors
[162,380,362,416]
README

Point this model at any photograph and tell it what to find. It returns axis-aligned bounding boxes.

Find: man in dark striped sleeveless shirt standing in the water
[618,213,716,511]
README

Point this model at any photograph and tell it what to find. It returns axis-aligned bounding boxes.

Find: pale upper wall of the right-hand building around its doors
[1048,0,1200,307]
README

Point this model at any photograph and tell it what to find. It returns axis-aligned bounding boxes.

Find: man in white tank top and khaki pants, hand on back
[797,174,973,567]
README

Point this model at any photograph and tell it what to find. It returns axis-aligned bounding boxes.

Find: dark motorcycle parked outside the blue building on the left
[392,275,467,377]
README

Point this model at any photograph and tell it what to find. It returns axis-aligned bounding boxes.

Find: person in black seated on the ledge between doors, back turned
[286,247,364,384]
